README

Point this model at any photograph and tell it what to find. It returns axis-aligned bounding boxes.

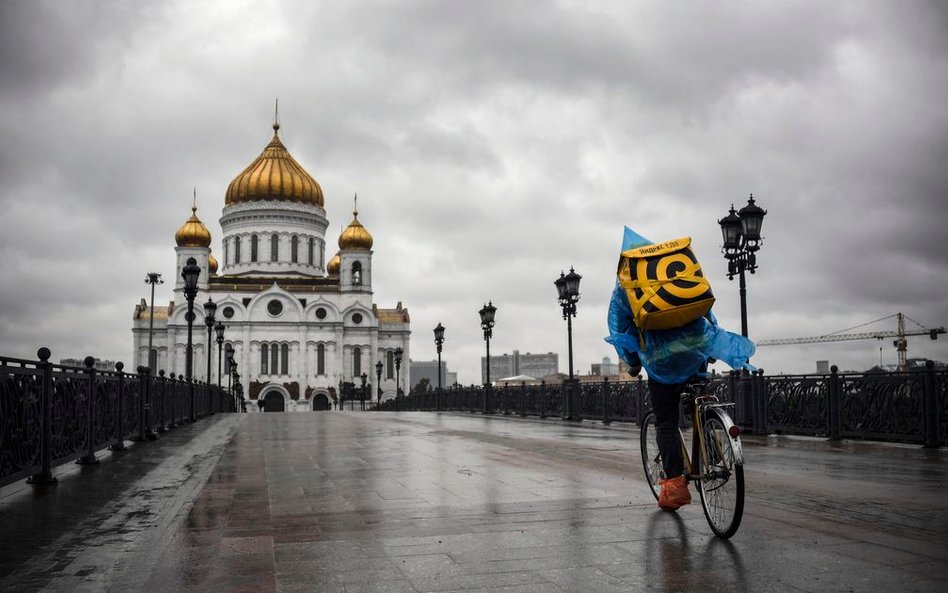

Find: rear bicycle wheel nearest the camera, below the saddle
[698,410,744,539]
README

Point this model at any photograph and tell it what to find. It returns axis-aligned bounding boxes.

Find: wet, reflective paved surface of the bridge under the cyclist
[0,412,948,592]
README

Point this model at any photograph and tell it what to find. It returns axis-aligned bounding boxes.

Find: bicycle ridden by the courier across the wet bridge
[641,379,744,539]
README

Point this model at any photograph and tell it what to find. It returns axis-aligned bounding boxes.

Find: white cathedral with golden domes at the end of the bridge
[132,118,411,411]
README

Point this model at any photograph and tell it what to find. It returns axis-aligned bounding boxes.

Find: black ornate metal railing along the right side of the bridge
[379,362,948,447]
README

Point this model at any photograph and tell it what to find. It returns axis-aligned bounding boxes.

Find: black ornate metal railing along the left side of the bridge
[0,348,235,486]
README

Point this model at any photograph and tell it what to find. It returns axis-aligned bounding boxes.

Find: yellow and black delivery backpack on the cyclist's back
[617,237,714,331]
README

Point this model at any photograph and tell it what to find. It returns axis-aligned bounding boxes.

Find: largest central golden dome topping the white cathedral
[224,123,323,206]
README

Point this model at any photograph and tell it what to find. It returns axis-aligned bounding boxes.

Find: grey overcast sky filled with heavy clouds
[0,0,948,383]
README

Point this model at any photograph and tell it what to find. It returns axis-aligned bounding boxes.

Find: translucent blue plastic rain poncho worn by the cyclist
[605,227,756,384]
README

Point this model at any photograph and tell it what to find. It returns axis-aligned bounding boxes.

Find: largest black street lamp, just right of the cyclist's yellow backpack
[718,194,767,338]
